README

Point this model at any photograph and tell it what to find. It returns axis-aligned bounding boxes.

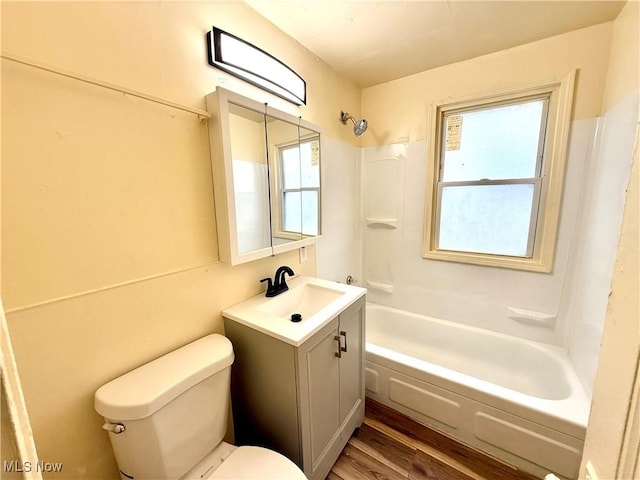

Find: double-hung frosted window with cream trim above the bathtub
[423,73,574,272]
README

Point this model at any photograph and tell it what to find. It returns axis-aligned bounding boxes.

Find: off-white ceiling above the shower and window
[245,0,625,87]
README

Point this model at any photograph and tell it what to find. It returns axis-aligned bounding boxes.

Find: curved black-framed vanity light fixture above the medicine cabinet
[207,27,307,105]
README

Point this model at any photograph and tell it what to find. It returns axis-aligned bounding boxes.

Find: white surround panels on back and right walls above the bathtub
[360,96,638,394]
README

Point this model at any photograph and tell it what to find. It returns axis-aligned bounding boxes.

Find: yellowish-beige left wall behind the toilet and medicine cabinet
[0,2,360,479]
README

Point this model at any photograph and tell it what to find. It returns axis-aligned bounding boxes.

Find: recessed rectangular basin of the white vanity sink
[258,283,345,321]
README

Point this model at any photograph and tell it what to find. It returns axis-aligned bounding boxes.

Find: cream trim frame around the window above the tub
[422,70,576,273]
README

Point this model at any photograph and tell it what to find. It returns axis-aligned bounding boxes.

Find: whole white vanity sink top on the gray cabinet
[222,277,366,346]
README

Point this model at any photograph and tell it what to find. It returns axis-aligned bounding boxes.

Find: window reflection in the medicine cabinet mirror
[278,137,320,236]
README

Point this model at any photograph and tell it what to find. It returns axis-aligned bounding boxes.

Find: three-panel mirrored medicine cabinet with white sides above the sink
[206,87,321,265]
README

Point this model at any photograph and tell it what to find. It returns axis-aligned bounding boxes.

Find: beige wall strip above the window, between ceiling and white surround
[362,22,612,146]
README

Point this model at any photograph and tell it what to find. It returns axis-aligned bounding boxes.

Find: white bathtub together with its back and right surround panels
[344,91,638,478]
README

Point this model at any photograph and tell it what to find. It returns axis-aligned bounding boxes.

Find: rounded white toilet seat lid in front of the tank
[207,446,307,480]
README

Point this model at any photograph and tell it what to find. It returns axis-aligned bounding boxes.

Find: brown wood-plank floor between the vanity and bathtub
[327,399,536,480]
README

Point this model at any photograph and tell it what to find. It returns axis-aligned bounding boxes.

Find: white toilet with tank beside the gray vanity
[94,334,307,480]
